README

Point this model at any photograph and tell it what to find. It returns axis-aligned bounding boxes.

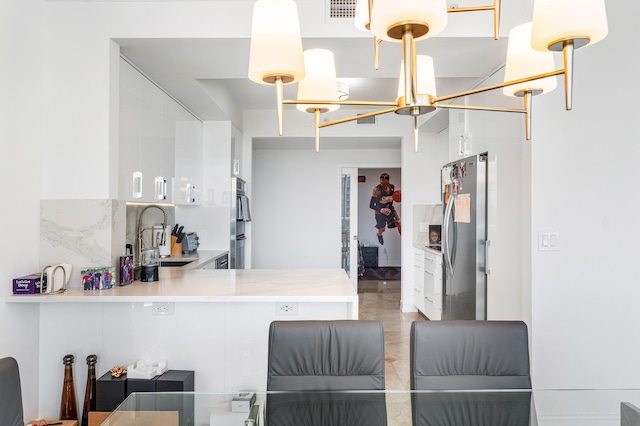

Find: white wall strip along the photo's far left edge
[0,0,44,418]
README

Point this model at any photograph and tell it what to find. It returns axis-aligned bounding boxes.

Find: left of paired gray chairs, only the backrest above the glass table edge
[267,320,384,391]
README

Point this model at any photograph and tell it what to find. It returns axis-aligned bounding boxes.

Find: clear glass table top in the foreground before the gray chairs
[103,389,640,426]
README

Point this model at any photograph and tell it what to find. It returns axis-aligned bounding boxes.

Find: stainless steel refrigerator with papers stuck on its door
[442,153,488,320]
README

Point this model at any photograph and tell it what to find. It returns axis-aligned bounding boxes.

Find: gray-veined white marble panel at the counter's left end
[39,199,126,287]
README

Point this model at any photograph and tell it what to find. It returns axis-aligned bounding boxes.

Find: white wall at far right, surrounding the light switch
[531,1,640,388]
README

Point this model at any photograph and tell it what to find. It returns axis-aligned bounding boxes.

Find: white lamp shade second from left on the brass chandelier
[296,49,340,111]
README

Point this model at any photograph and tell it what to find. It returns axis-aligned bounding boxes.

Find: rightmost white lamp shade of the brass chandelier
[531,0,609,51]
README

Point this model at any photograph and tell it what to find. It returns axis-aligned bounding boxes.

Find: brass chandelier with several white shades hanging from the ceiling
[249,0,608,152]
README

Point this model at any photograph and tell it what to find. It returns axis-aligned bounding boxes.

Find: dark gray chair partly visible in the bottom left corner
[0,357,24,426]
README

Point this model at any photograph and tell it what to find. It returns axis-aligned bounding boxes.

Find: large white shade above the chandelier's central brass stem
[368,0,448,42]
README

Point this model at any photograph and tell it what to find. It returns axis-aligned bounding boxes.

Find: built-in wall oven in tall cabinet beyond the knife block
[229,177,251,269]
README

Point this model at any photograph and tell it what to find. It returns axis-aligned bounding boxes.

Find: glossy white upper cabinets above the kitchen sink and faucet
[118,59,202,204]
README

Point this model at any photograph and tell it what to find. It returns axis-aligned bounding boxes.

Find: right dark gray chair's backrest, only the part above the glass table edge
[410,321,531,390]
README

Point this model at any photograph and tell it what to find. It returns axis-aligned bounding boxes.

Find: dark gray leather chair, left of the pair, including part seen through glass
[265,320,387,426]
